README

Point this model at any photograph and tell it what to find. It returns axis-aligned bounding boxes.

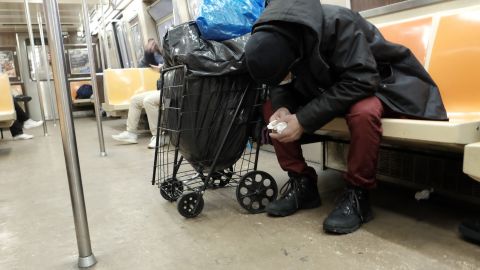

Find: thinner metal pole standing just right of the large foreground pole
[82,0,107,157]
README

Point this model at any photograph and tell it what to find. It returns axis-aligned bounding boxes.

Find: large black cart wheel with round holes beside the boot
[237,171,278,214]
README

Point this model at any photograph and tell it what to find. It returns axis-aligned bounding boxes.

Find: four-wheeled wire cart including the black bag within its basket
[152,66,278,218]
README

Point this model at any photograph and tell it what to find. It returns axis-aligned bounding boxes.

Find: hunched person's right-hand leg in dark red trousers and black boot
[323,96,384,233]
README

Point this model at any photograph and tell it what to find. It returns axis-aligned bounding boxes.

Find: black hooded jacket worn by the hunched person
[253,0,448,132]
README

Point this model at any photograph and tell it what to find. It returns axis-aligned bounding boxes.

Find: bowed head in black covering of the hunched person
[245,24,301,85]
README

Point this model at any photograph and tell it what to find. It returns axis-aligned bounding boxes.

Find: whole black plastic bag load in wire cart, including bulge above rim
[163,23,260,172]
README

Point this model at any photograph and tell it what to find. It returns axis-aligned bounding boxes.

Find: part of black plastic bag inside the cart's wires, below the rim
[163,70,259,171]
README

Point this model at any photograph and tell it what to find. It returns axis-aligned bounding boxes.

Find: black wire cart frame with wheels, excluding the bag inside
[152,66,278,218]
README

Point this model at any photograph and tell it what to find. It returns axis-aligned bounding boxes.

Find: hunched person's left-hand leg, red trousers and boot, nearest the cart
[263,101,321,216]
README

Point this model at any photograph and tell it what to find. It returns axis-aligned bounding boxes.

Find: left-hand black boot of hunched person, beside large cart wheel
[265,176,321,217]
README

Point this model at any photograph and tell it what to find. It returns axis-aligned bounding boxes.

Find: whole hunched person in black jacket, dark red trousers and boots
[245,0,447,233]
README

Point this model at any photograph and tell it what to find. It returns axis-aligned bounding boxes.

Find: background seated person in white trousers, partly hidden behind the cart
[112,39,167,149]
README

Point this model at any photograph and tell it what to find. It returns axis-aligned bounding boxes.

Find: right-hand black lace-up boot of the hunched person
[323,187,373,234]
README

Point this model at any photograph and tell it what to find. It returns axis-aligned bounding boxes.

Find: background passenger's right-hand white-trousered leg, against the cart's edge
[143,91,168,149]
